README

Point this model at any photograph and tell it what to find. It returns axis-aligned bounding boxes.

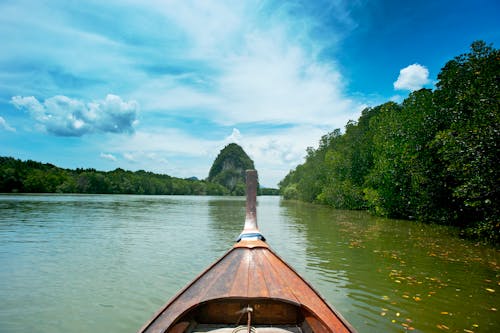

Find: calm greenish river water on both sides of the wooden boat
[0,195,500,333]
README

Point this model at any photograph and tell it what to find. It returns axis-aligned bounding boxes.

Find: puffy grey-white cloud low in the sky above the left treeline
[11,94,139,136]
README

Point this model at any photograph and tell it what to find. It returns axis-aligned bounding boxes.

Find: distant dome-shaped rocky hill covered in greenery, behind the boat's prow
[207,143,255,195]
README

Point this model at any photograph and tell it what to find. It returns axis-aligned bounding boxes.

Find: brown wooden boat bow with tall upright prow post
[138,170,356,333]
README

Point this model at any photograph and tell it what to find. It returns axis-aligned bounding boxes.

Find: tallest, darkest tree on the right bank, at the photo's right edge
[434,41,500,241]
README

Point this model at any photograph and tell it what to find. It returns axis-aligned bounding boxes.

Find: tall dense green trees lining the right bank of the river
[280,41,500,245]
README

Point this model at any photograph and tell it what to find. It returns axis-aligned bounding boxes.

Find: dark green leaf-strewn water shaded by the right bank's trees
[281,198,500,332]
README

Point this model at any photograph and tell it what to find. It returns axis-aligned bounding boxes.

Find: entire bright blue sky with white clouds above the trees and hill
[0,0,500,186]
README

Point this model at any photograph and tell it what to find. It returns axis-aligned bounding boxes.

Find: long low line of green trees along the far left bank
[0,157,229,195]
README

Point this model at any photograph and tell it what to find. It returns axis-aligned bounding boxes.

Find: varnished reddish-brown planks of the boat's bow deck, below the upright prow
[139,242,351,332]
